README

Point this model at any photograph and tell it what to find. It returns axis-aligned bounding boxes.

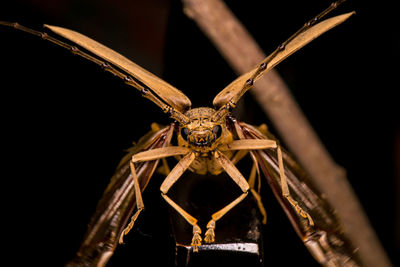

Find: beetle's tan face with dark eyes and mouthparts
[178,108,226,152]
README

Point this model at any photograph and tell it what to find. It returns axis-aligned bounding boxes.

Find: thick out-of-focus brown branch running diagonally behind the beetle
[182,0,391,267]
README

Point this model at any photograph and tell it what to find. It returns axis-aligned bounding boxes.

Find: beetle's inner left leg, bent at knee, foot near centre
[160,152,202,252]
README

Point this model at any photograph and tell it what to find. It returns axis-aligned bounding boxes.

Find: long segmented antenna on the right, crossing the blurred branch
[213,0,346,121]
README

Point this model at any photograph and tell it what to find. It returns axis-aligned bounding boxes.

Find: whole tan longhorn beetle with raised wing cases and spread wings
[0,1,357,266]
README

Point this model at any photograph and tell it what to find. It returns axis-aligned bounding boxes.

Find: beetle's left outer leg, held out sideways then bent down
[119,146,190,244]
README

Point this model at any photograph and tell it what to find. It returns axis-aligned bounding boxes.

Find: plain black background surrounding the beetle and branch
[0,0,400,266]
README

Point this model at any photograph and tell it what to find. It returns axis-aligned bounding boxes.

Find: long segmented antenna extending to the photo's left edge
[0,21,189,124]
